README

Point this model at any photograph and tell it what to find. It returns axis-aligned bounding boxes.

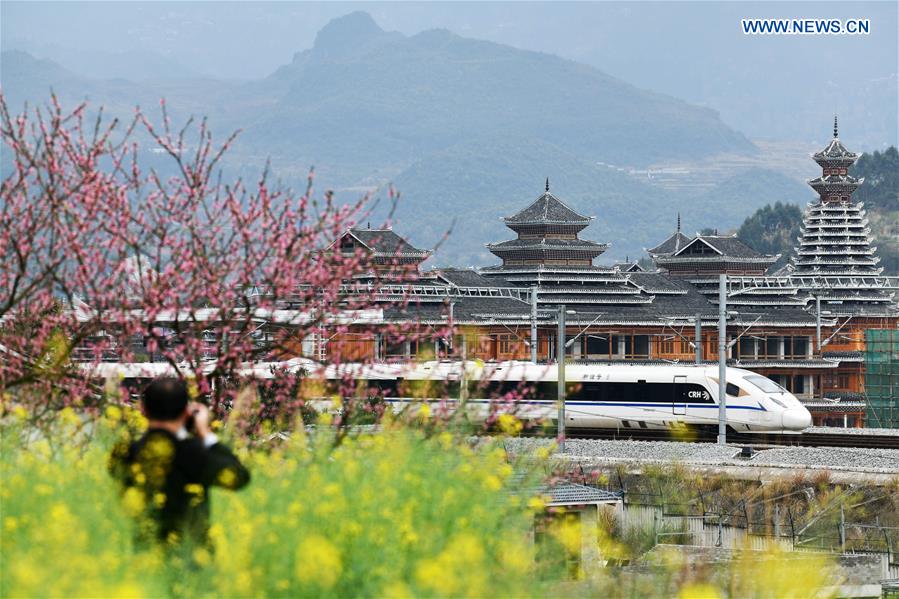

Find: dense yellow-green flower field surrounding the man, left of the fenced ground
[0,410,539,597]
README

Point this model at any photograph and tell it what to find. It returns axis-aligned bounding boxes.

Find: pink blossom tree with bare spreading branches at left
[0,96,436,432]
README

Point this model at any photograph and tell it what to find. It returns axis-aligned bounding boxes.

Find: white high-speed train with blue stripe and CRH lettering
[93,359,812,433]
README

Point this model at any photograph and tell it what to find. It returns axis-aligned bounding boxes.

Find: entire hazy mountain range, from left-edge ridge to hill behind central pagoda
[2,12,768,264]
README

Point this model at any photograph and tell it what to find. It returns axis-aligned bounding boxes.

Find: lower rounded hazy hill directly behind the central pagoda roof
[395,137,673,266]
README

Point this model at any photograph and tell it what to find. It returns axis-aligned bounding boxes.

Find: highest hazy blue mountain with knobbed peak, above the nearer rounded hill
[247,13,754,177]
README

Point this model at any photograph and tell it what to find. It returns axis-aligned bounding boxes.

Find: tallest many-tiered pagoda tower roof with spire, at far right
[791,118,894,314]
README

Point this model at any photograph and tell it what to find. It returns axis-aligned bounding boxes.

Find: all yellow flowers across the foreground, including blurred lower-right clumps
[0,406,839,598]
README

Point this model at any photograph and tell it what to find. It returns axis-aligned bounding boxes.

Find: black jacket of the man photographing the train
[109,429,250,544]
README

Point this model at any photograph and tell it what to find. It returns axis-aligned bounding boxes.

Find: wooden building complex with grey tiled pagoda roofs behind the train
[312,126,899,426]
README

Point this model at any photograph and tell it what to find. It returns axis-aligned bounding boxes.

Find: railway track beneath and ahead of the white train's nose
[545,428,899,449]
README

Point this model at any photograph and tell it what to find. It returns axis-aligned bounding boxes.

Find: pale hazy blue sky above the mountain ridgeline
[0,1,899,147]
